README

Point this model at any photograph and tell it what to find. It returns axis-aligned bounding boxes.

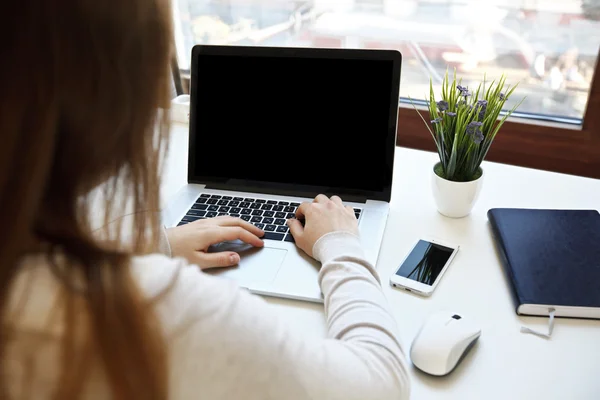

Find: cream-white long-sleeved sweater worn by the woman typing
[7,233,409,400]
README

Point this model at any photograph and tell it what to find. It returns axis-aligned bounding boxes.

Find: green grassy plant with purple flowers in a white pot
[415,71,523,218]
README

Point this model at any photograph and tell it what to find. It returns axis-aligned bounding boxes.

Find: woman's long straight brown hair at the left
[0,0,172,399]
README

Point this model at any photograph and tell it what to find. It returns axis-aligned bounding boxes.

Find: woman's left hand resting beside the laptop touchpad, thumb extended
[167,216,265,269]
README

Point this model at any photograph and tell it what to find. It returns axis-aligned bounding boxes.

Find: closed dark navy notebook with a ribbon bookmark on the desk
[488,208,600,319]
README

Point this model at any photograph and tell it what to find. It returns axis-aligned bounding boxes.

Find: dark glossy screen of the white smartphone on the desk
[396,240,454,286]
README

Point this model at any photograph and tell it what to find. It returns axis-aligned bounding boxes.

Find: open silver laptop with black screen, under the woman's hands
[163,45,401,302]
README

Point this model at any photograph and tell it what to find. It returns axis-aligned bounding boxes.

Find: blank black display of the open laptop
[190,49,397,200]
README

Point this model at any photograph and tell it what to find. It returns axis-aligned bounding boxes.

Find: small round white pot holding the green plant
[431,163,484,218]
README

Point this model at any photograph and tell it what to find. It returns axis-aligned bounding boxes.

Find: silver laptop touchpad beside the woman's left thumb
[204,242,287,286]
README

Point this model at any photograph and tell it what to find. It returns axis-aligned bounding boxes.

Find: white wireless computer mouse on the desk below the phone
[410,311,481,376]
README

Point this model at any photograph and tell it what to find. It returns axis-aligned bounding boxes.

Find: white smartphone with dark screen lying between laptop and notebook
[390,239,459,296]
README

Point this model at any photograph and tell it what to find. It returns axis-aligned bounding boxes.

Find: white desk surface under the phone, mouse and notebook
[162,125,600,400]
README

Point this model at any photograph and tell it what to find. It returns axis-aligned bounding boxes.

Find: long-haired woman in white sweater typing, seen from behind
[0,0,409,399]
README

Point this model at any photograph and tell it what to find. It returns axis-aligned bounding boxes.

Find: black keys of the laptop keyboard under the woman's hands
[177,193,362,242]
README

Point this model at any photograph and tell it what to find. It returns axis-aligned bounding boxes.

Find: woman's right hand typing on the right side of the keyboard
[288,194,358,257]
